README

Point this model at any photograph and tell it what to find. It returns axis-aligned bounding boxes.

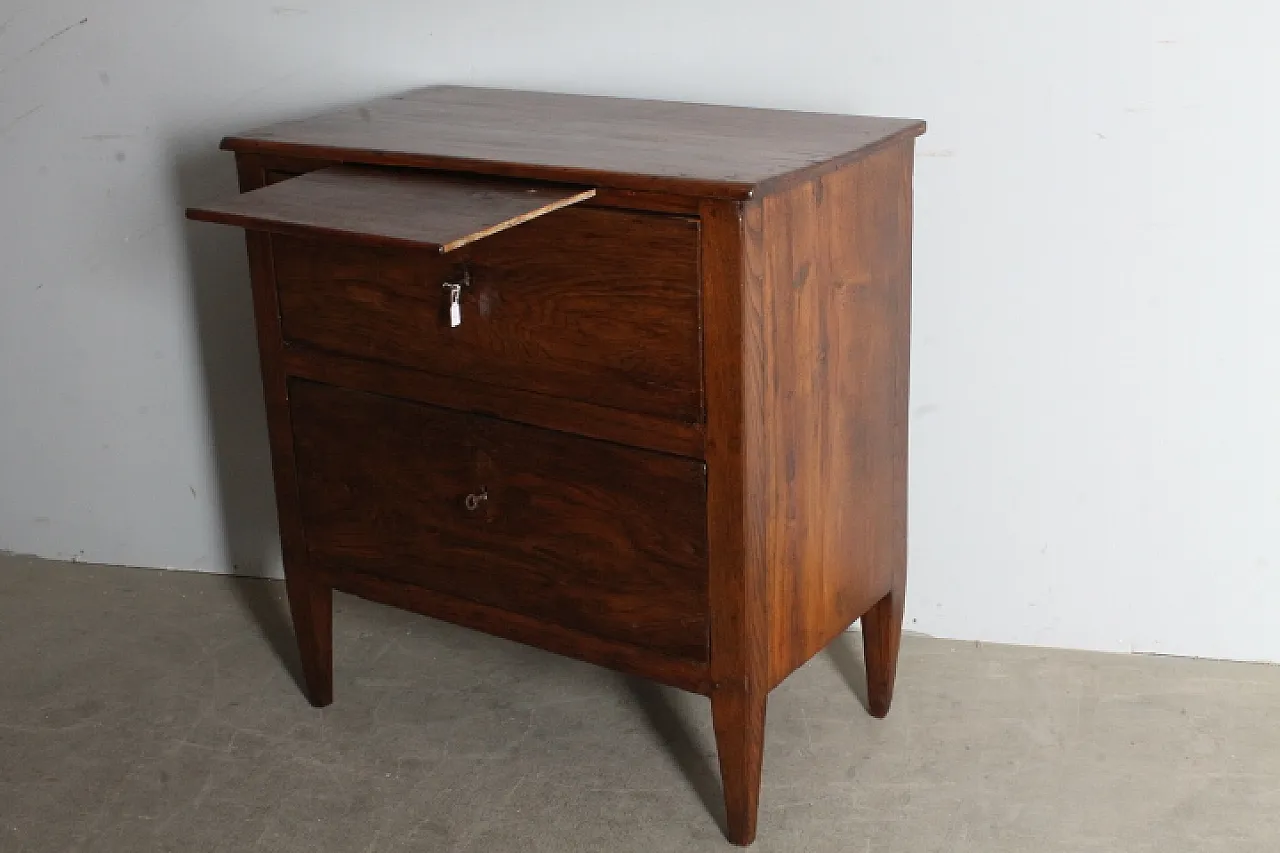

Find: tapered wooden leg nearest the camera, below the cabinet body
[712,688,768,847]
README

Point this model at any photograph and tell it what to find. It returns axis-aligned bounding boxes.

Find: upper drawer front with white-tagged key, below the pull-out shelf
[271,203,701,421]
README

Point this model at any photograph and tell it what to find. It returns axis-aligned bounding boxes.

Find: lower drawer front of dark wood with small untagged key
[289,379,708,661]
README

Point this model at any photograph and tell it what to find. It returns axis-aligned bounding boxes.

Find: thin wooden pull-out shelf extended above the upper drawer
[187,165,595,254]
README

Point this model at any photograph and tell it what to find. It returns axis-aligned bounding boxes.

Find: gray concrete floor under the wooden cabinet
[0,556,1280,853]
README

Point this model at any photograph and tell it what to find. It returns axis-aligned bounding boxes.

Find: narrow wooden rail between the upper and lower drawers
[284,346,704,459]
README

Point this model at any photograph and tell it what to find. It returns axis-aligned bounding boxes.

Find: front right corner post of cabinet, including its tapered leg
[701,201,769,845]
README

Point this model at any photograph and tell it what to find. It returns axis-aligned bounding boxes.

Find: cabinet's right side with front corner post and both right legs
[701,141,913,844]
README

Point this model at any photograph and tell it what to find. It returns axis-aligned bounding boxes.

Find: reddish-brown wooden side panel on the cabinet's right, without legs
[749,141,914,684]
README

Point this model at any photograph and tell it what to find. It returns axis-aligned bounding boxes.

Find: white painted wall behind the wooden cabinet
[0,0,1280,661]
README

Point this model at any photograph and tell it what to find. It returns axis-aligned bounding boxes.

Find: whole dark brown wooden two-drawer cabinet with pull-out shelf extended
[188,87,924,844]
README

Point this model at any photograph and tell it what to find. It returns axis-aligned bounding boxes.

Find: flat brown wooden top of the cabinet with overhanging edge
[223,86,924,199]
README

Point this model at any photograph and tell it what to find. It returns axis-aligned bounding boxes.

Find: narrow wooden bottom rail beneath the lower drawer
[317,567,710,694]
